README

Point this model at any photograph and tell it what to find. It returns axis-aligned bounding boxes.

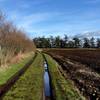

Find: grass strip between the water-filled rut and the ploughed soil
[45,54,85,100]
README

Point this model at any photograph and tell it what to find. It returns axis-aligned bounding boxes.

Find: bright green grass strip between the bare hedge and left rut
[0,53,33,85]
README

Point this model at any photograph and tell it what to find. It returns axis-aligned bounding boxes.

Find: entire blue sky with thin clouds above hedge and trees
[0,0,100,38]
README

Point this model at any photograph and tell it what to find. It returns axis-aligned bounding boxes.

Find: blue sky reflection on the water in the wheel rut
[44,62,51,97]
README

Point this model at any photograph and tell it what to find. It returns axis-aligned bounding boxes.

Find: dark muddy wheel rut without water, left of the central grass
[0,54,37,100]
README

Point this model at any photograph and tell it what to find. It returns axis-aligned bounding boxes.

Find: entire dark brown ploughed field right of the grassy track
[44,49,100,100]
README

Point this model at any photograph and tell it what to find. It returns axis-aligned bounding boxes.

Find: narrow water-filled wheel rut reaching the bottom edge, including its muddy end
[44,61,51,100]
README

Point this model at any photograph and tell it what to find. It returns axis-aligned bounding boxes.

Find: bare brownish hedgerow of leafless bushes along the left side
[0,12,35,65]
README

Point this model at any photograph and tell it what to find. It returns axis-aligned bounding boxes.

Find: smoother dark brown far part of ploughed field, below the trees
[46,49,100,72]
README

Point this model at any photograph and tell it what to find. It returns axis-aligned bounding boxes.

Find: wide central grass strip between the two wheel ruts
[3,53,43,100]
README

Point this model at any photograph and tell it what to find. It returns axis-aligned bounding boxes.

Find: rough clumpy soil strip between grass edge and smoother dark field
[48,55,100,100]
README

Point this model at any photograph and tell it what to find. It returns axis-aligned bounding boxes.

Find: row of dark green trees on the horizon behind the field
[33,35,100,48]
